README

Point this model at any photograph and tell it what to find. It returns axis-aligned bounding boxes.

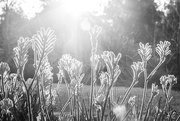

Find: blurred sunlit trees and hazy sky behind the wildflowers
[0,0,180,90]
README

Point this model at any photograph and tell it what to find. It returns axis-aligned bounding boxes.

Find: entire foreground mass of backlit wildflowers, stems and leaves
[0,26,180,121]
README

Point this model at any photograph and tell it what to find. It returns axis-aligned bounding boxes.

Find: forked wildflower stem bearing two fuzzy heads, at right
[138,41,171,120]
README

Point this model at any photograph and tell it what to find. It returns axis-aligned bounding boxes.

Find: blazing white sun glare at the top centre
[62,0,108,17]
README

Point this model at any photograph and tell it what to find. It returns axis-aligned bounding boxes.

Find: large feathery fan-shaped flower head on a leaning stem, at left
[28,28,56,91]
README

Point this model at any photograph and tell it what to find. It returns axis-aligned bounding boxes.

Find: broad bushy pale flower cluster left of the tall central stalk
[58,54,84,93]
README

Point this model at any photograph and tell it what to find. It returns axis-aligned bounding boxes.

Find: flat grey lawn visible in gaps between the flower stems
[53,84,180,113]
